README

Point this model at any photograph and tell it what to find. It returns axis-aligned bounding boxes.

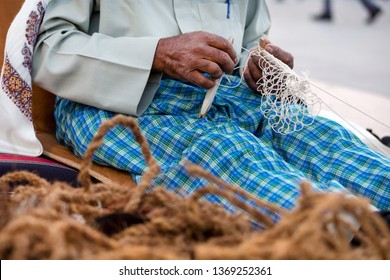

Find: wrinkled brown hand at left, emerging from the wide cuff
[152,31,238,89]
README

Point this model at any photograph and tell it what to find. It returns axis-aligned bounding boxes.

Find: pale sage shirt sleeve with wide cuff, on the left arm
[32,0,161,116]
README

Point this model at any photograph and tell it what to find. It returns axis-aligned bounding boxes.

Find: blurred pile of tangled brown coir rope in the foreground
[0,116,390,259]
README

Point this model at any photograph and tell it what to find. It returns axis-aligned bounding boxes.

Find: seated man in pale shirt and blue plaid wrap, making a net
[33,0,390,223]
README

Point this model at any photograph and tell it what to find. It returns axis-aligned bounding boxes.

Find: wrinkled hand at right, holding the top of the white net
[243,40,294,92]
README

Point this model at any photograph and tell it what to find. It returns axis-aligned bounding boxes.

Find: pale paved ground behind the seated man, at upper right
[267,0,390,137]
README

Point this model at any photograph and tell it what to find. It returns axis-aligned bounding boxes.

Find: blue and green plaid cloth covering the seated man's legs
[56,77,390,221]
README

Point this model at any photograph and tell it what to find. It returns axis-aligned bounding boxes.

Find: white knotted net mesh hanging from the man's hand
[252,47,321,134]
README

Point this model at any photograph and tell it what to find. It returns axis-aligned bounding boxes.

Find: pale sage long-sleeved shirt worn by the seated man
[33,0,270,116]
